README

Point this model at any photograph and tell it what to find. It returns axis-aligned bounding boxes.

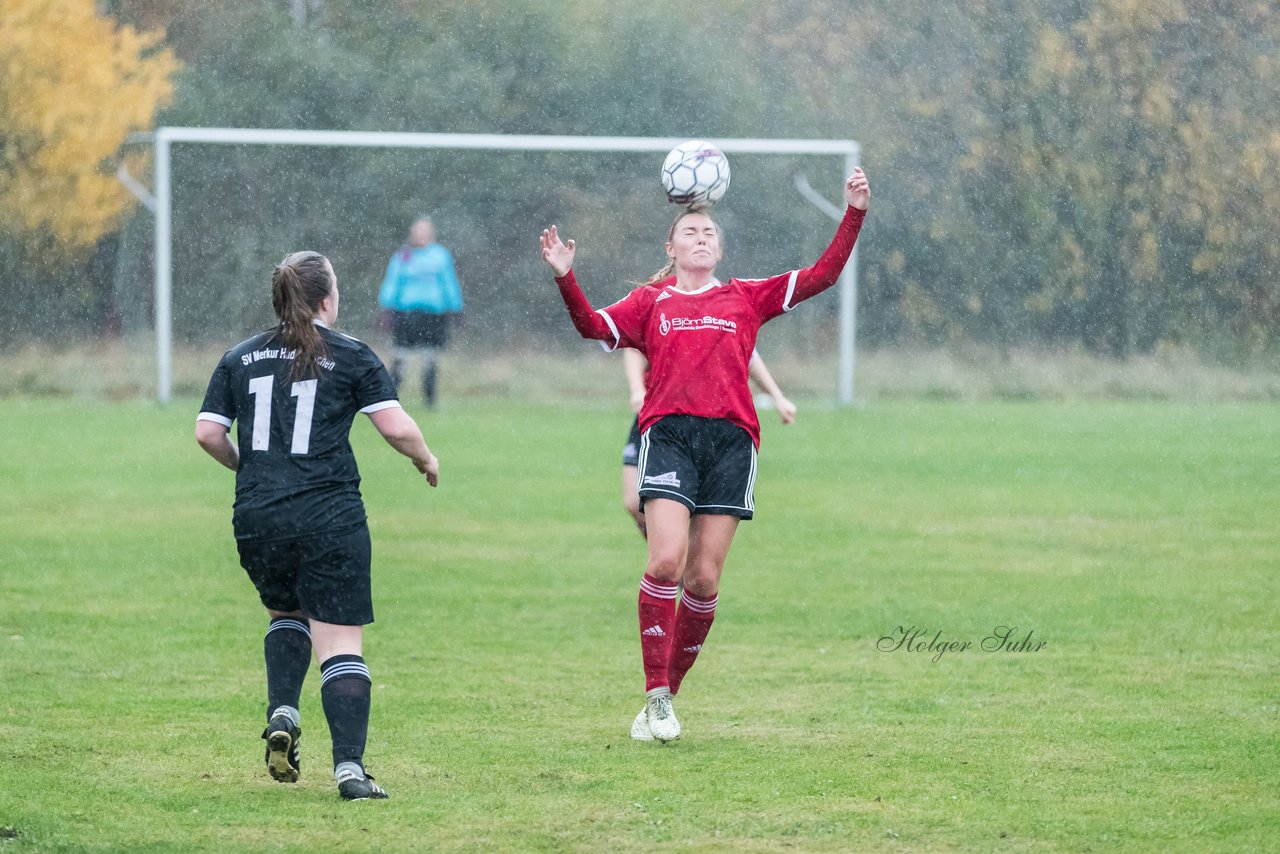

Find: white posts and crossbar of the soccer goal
[152,127,861,406]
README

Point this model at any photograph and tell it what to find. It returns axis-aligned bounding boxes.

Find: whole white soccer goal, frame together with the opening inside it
[123,128,859,403]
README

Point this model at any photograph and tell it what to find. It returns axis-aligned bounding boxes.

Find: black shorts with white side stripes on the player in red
[639,415,755,519]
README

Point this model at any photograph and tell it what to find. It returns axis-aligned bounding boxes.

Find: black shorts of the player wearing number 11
[236,524,374,626]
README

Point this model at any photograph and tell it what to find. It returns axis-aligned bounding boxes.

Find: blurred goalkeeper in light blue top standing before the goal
[378,216,462,406]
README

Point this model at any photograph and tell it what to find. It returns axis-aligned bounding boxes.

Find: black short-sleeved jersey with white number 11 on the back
[197,325,399,540]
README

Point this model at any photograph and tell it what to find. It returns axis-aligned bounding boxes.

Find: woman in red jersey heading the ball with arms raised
[540,169,870,741]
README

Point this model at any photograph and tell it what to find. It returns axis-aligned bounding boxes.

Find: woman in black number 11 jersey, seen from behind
[196,252,440,800]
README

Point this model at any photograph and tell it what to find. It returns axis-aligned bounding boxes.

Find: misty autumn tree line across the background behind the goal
[0,0,1280,357]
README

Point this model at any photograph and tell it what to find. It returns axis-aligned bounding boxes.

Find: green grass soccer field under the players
[0,398,1280,853]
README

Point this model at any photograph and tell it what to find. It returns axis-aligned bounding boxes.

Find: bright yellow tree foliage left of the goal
[0,0,179,256]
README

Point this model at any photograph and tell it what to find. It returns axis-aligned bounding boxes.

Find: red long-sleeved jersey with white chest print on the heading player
[556,207,865,446]
